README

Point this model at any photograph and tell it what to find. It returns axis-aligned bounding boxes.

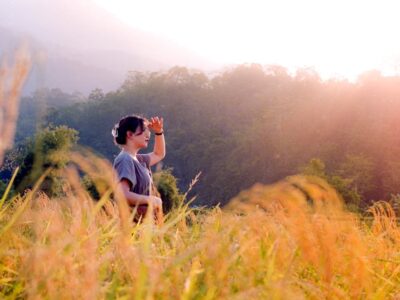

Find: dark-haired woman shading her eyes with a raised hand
[112,115,166,221]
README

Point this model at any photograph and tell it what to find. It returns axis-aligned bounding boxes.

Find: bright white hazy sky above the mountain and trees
[93,0,400,79]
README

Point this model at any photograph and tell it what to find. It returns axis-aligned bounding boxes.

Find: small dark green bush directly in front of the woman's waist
[153,169,184,212]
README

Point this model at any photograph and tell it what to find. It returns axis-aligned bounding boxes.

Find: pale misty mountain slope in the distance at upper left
[0,0,216,94]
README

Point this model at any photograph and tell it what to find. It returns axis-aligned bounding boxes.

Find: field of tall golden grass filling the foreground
[0,168,400,299]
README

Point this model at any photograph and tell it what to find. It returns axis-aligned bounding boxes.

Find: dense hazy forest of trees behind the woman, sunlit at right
[2,65,400,207]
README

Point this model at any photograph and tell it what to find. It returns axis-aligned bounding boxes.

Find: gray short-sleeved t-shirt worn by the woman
[113,151,152,196]
